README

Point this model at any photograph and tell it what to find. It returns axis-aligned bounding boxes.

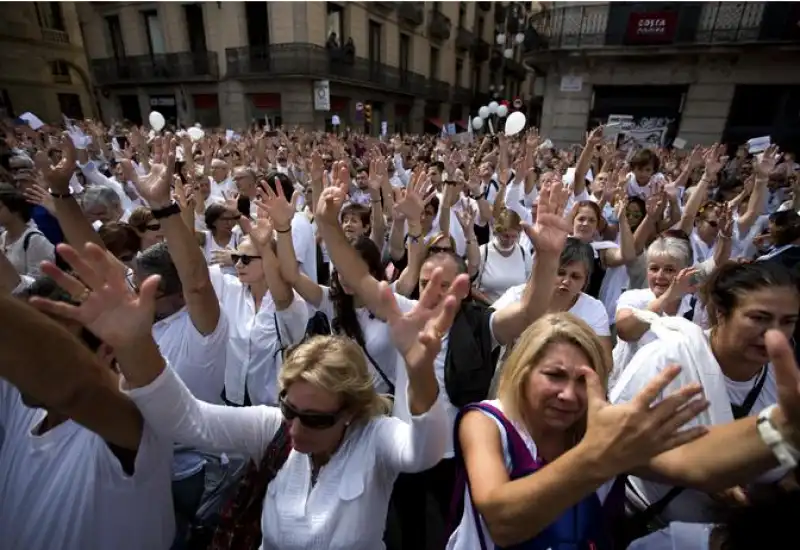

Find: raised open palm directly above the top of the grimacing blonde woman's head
[522,182,572,256]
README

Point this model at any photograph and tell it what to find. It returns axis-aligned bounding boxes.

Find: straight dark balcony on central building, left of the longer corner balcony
[91,52,219,86]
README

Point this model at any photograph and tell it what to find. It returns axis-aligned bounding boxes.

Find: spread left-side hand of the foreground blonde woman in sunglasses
[30,244,159,348]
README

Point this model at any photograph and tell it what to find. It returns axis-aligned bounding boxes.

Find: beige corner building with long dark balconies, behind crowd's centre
[78,2,528,134]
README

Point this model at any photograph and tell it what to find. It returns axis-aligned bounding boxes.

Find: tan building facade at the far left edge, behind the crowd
[0,2,96,123]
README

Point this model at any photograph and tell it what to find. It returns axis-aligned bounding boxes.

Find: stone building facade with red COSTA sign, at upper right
[525,2,800,151]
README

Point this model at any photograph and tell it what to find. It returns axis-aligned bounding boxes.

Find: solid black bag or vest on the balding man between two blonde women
[444,301,496,407]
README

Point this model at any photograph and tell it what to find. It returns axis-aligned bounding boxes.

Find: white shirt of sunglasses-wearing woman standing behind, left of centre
[208,266,309,405]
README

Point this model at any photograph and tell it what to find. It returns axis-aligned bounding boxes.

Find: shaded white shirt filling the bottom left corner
[0,379,175,550]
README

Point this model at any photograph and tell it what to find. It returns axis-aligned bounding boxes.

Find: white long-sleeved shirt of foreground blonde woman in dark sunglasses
[130,369,447,550]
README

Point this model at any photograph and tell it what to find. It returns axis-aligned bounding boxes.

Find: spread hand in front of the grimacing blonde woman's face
[580,365,708,478]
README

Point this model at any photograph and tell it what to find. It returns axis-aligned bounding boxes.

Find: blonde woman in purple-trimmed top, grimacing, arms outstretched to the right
[447,313,800,550]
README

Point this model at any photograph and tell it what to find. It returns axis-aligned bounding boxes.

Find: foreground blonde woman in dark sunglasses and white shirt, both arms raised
[31,239,469,550]
